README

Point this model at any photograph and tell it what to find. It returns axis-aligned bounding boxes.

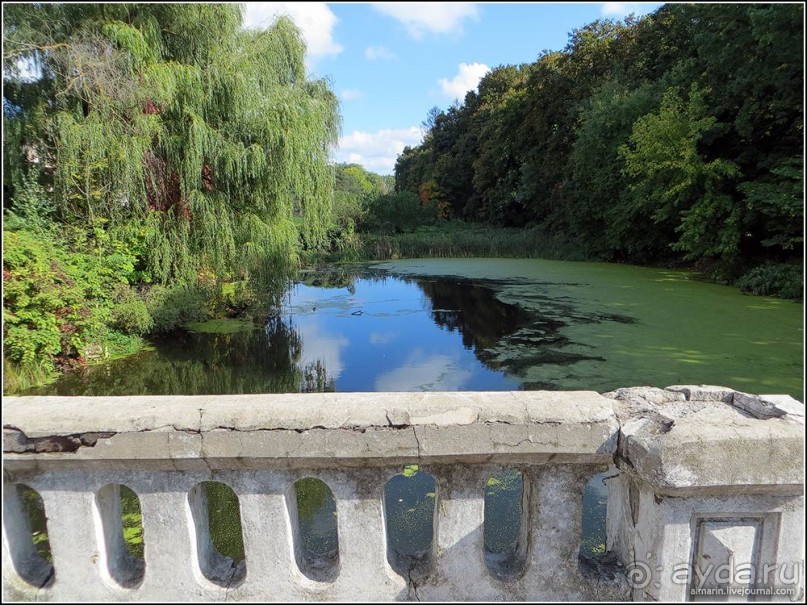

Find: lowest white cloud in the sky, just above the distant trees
[336,126,423,174]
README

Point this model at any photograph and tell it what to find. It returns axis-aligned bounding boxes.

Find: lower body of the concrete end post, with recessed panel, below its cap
[606,473,804,602]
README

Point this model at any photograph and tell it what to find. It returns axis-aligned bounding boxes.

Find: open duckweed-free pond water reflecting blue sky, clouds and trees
[26,272,527,396]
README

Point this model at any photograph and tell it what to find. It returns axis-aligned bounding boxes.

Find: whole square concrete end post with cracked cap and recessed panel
[608,386,804,602]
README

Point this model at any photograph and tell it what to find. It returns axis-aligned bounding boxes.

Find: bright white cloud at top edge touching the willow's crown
[244,2,342,60]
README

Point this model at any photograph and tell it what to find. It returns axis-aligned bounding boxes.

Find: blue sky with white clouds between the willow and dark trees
[244,2,662,174]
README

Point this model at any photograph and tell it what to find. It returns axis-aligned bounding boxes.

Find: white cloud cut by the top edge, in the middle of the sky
[372,2,479,38]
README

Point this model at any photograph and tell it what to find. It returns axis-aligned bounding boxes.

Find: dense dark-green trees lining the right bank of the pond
[395,4,804,296]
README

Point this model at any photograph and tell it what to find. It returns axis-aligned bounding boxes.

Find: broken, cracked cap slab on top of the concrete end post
[606,386,804,496]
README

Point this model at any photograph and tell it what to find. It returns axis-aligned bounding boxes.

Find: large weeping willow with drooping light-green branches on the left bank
[3,4,339,282]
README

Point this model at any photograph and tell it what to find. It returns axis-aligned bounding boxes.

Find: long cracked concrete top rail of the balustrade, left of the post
[3,391,618,470]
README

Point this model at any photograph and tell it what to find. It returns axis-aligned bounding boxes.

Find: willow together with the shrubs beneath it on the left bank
[3,3,340,386]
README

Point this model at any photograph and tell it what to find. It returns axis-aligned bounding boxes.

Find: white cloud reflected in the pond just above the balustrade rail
[375,351,473,391]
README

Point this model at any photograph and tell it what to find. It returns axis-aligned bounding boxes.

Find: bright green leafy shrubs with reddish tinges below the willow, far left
[3,226,150,380]
